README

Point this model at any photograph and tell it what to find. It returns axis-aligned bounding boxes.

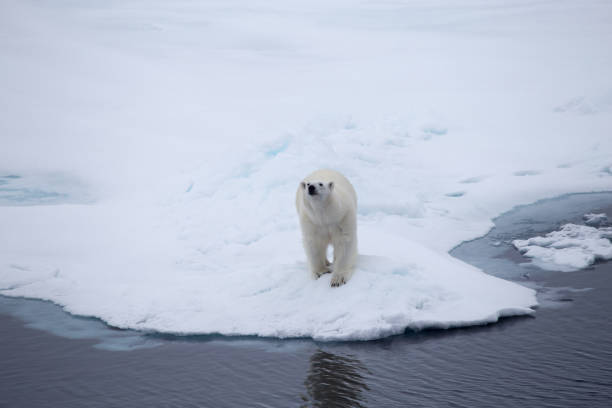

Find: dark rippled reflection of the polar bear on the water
[302,350,369,408]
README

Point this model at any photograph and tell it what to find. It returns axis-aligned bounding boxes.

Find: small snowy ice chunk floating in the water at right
[512,223,612,272]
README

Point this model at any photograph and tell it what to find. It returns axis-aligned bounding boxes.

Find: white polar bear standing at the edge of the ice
[295,170,357,287]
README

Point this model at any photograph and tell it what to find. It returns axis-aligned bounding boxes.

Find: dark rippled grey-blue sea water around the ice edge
[0,193,612,407]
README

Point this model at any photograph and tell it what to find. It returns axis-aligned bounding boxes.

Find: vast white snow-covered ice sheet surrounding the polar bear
[0,0,612,339]
